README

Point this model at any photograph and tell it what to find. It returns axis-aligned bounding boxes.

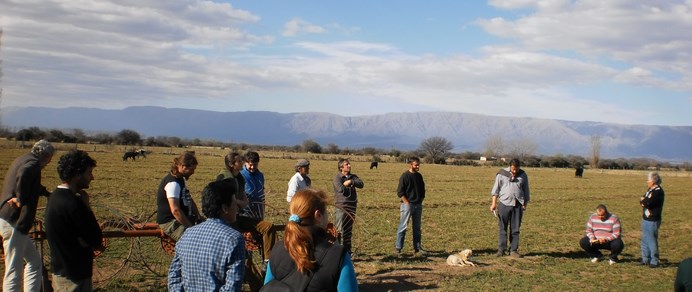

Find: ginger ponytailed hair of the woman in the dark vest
[284,188,327,274]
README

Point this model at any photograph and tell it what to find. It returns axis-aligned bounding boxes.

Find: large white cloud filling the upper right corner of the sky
[477,0,692,90]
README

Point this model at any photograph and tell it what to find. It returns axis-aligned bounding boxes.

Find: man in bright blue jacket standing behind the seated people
[240,151,264,219]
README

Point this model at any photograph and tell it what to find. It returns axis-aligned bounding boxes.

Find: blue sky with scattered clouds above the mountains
[0,0,692,126]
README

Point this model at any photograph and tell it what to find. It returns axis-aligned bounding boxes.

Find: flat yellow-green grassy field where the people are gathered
[0,142,692,291]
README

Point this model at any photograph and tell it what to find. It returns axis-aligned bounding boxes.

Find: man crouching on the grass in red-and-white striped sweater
[579,204,625,265]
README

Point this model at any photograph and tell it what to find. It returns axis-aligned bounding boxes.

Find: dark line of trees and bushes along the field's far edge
[0,127,692,171]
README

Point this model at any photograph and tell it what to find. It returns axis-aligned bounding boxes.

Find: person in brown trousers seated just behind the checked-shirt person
[216,152,276,291]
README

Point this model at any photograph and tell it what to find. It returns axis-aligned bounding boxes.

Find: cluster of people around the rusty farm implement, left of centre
[157,151,364,291]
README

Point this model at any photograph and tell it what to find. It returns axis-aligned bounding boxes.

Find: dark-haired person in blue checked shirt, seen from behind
[168,180,245,291]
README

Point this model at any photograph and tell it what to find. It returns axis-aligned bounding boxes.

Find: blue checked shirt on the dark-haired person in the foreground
[168,218,245,291]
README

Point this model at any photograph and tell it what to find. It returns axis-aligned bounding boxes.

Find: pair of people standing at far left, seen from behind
[0,140,103,291]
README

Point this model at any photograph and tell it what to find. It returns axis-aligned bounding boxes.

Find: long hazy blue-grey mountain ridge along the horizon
[0,107,692,161]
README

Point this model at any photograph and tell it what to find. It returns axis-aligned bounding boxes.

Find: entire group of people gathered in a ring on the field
[0,140,680,291]
